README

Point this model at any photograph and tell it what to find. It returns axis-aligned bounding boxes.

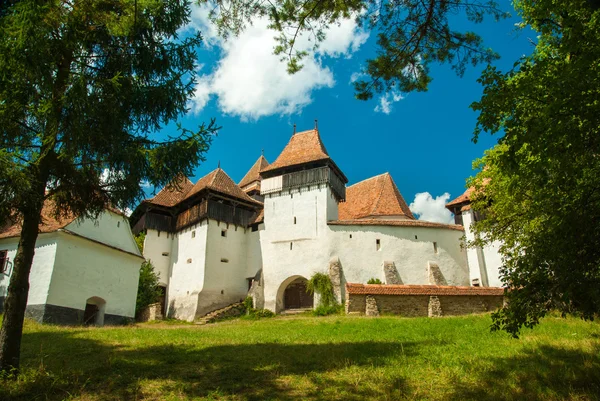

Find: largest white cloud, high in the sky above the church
[186,5,368,120]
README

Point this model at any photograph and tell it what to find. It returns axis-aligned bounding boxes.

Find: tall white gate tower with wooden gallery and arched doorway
[260,127,348,312]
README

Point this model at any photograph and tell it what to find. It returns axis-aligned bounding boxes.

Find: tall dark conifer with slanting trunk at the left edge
[0,0,217,370]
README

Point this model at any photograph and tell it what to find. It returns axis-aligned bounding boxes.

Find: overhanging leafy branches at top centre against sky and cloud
[209,0,507,100]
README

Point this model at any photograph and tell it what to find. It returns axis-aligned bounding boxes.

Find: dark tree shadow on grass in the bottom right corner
[449,345,600,401]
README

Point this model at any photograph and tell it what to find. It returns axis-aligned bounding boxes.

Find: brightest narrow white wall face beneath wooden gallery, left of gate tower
[166,220,208,321]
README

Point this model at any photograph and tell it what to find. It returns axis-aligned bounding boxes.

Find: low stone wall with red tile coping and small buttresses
[346,284,504,317]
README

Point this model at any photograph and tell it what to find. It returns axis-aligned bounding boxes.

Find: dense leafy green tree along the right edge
[471,0,600,336]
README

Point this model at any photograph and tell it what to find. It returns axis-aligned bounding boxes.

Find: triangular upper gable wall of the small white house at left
[65,211,140,255]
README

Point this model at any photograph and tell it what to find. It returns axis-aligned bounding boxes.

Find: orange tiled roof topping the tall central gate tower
[262,129,330,171]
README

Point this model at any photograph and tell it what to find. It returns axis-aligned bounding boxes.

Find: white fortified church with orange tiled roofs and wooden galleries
[133,128,502,320]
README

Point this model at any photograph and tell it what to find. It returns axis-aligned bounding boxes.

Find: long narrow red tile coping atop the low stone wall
[346,283,504,296]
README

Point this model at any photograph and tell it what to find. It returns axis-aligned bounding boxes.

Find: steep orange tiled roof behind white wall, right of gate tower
[338,173,415,220]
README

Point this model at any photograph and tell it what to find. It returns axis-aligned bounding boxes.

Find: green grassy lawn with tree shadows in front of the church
[0,316,600,400]
